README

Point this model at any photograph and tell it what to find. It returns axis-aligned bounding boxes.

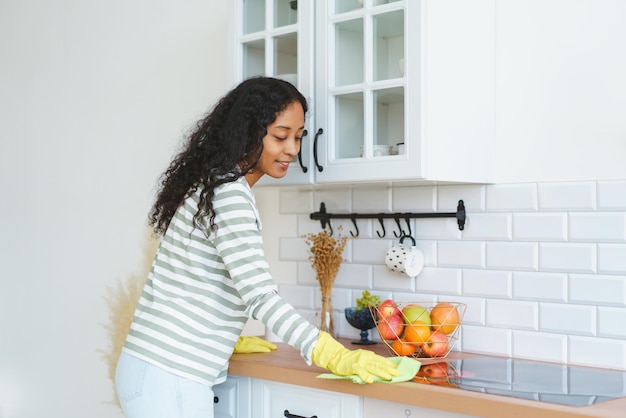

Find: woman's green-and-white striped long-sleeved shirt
[123,177,319,385]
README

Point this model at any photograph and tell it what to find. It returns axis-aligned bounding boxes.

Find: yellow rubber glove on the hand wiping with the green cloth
[312,331,400,383]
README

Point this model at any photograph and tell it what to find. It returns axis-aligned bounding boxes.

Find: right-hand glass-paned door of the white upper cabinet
[318,0,406,171]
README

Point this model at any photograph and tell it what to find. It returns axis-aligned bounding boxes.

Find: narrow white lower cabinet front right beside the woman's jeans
[213,375,252,418]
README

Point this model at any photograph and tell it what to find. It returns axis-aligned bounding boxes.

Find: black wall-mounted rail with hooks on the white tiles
[309,200,465,238]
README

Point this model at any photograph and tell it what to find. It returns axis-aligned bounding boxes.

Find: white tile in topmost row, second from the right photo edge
[538,182,596,211]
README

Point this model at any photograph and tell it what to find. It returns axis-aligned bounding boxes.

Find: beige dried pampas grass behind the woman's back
[98,230,158,405]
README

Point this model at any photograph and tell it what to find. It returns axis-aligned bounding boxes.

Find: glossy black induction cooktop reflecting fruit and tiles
[415,356,626,406]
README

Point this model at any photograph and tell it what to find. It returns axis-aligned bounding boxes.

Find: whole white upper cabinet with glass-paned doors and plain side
[231,0,495,185]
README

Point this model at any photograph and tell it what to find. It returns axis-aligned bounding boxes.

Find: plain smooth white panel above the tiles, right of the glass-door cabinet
[494,0,626,182]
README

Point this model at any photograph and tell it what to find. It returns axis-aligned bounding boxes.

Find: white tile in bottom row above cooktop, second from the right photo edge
[513,331,567,363]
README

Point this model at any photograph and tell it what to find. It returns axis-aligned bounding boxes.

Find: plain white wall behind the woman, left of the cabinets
[0,0,228,418]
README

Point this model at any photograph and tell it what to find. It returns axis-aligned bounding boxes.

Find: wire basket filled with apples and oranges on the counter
[370,299,466,358]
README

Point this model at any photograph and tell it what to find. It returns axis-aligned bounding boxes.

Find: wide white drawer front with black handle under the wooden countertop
[250,379,363,418]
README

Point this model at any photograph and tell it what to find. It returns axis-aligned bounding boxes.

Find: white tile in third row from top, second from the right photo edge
[539,243,597,273]
